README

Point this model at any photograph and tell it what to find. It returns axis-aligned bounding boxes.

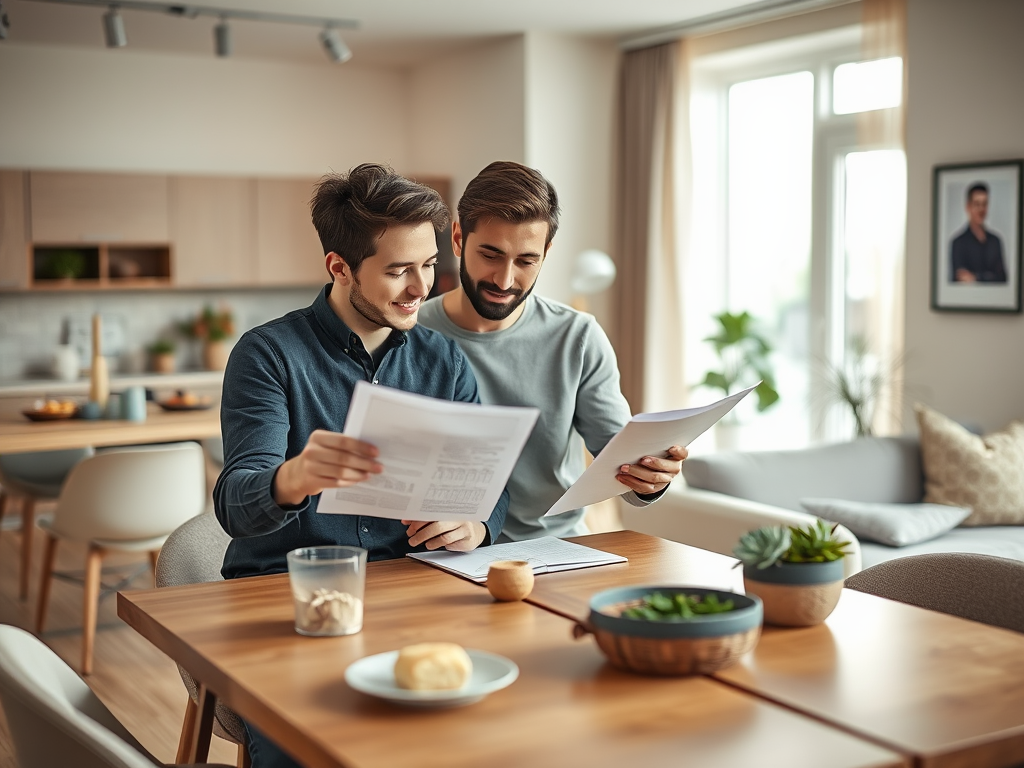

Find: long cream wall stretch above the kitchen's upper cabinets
[0,42,410,175]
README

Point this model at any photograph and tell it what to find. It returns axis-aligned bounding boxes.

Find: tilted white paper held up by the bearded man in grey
[545,382,760,517]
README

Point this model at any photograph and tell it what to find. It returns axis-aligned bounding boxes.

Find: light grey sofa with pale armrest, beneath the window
[623,436,1024,575]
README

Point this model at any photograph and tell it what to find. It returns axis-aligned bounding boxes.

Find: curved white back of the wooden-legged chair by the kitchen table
[50,442,206,541]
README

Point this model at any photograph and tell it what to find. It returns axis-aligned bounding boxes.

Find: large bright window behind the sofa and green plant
[684,28,906,450]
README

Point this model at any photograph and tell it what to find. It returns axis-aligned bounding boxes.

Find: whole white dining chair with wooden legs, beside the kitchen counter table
[36,442,206,675]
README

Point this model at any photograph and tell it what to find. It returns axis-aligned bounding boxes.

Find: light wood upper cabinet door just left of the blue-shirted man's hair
[256,178,328,286]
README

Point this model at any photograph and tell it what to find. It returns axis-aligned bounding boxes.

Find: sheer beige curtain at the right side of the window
[857,0,907,434]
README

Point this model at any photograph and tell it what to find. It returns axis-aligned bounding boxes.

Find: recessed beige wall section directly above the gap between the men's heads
[408,36,525,205]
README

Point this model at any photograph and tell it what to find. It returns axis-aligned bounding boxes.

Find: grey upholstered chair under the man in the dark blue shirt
[157,513,249,766]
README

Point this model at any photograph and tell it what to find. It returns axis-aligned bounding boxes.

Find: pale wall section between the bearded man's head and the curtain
[525,32,620,309]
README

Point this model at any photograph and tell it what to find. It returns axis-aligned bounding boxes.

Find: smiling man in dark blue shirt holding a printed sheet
[214,164,508,579]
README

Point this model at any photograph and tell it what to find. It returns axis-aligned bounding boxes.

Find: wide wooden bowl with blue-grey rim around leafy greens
[573,586,762,676]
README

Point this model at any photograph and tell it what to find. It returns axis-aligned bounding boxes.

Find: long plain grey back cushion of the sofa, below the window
[682,437,924,512]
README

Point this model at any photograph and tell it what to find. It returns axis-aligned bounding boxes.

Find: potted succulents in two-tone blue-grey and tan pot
[732,520,850,627]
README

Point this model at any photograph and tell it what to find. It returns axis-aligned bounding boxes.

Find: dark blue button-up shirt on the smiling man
[213,285,508,579]
